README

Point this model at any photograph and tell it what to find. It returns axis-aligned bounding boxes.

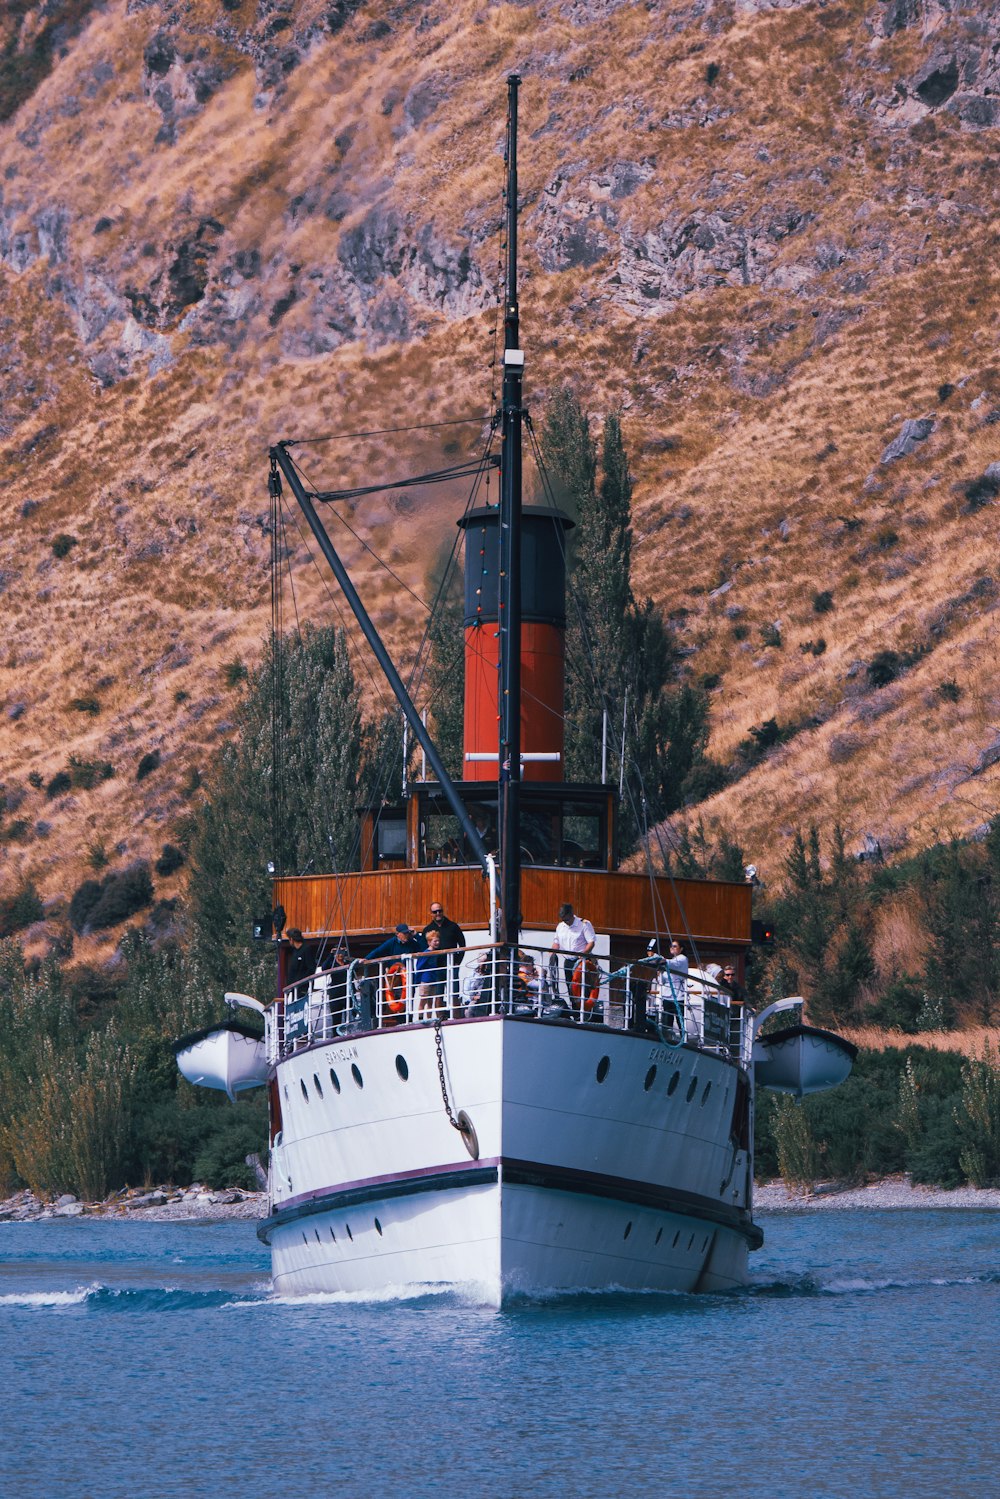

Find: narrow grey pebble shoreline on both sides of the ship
[0,1177,1000,1223]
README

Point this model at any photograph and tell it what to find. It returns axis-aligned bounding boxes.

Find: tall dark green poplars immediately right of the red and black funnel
[543,388,708,841]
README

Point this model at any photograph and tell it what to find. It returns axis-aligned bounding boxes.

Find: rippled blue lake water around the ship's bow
[0,1210,1000,1499]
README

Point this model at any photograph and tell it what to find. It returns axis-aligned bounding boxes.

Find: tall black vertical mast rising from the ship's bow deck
[499,73,525,943]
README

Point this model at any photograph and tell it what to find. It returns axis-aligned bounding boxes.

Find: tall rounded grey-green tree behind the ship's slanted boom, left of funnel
[189,627,363,992]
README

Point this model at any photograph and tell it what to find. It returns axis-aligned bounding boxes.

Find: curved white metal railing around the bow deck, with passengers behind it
[265,943,753,1067]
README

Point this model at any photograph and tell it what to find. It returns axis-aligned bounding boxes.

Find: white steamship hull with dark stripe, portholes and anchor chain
[262,1016,759,1304]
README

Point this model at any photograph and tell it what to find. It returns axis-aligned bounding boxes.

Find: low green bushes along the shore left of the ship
[0,932,267,1199]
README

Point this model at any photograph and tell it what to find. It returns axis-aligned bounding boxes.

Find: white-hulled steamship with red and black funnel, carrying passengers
[178,76,850,1306]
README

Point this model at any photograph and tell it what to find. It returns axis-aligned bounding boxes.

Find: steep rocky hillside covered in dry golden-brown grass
[0,0,1000,946]
